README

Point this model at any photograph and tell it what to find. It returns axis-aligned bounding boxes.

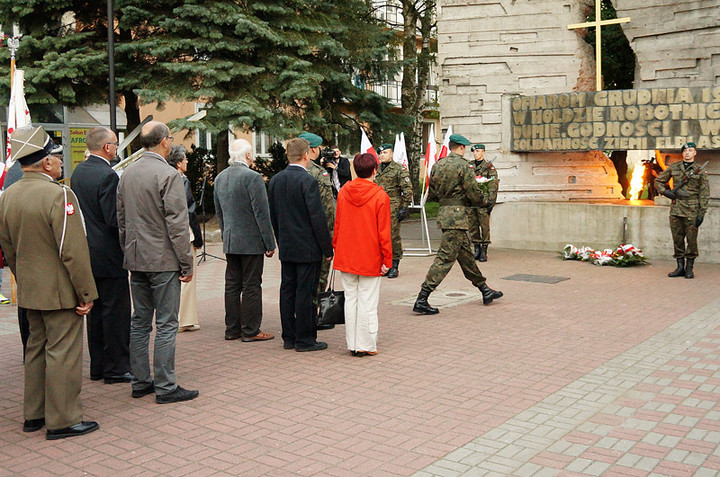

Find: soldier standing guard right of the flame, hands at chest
[655,142,710,278]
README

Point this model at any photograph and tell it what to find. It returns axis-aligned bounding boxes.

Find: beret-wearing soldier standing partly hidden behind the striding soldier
[468,144,500,262]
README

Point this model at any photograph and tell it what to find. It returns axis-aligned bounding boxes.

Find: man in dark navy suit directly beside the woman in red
[269,138,333,351]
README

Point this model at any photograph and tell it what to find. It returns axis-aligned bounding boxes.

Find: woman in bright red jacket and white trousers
[333,154,392,356]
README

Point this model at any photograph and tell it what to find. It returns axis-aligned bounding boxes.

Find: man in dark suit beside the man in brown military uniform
[71,127,132,384]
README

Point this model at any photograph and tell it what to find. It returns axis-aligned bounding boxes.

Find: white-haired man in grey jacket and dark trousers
[215,139,275,342]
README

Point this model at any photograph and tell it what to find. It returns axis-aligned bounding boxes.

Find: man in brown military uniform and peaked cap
[0,127,98,439]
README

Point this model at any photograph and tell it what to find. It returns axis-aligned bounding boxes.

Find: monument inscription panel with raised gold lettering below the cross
[511,87,720,152]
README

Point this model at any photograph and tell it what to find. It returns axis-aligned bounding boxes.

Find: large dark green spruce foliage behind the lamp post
[0,0,403,169]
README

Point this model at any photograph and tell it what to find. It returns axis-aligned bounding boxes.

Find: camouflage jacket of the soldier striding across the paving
[428,152,487,230]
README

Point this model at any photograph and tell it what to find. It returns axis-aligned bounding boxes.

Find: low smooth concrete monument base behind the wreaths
[490,200,720,263]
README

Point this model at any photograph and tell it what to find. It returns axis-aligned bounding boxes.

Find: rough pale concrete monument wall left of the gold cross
[438,0,621,201]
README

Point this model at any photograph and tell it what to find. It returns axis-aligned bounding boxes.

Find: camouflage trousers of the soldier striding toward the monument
[422,229,485,292]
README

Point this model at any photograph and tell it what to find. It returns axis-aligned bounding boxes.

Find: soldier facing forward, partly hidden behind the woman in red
[375,144,412,278]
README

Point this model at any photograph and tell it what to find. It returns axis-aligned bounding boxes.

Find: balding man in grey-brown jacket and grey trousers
[117,121,198,404]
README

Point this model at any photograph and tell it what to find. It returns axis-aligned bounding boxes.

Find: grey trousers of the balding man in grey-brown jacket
[130,272,180,395]
